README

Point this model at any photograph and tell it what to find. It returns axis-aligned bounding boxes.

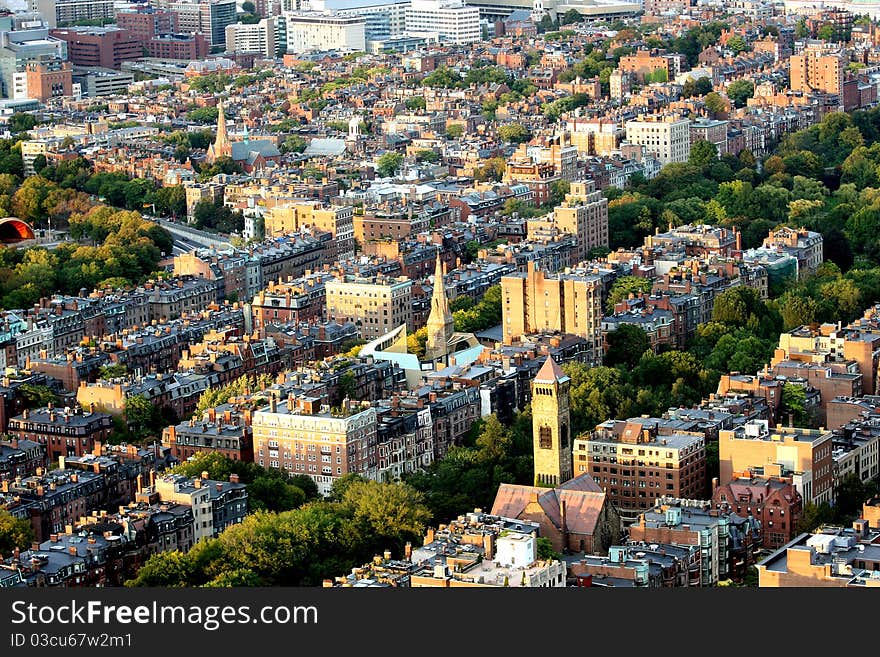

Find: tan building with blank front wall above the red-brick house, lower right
[718,420,834,504]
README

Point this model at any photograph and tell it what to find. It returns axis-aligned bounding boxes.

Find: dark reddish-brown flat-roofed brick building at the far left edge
[8,402,113,461]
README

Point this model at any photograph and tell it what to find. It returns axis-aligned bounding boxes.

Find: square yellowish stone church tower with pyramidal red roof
[532,356,574,486]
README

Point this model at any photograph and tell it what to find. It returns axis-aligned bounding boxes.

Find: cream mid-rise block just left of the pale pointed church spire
[325,275,414,340]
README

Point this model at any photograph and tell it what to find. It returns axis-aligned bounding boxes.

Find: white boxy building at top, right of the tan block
[284,11,367,53]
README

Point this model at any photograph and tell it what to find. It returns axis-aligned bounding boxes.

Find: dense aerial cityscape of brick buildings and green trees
[0,0,880,588]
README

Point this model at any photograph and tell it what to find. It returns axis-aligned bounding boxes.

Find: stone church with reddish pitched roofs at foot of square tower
[491,474,621,554]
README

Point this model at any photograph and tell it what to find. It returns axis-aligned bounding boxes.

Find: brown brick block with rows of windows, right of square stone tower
[574,418,706,522]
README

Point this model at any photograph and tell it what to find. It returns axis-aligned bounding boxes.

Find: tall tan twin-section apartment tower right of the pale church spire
[501,262,602,363]
